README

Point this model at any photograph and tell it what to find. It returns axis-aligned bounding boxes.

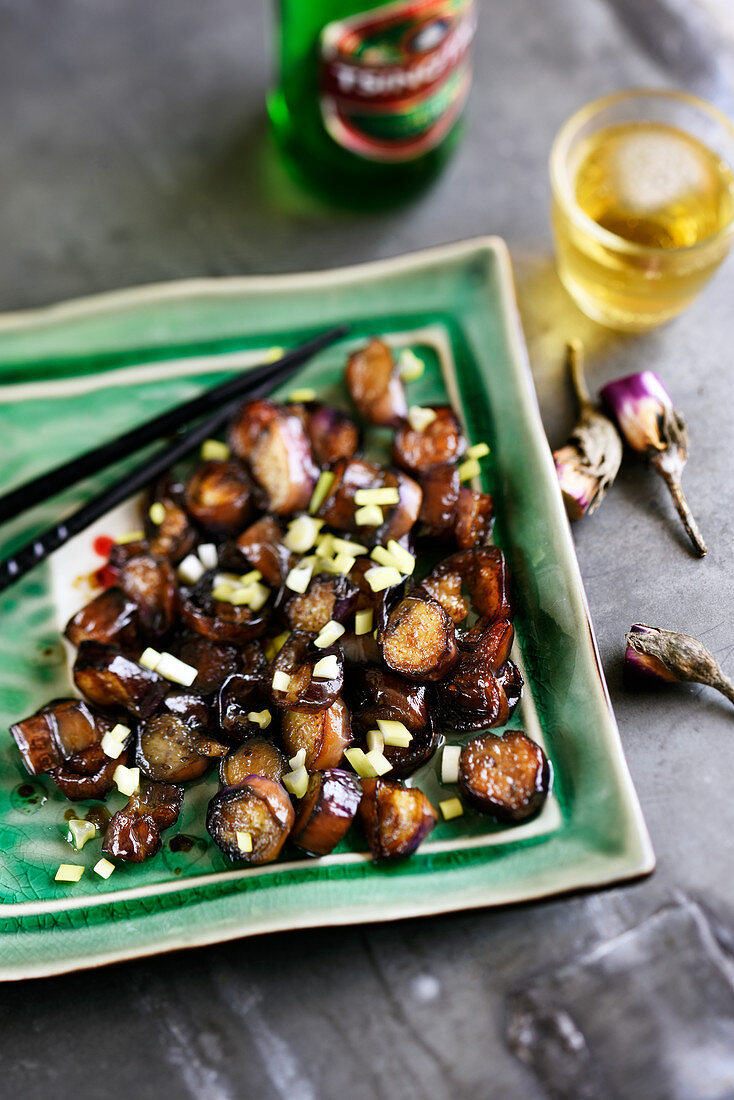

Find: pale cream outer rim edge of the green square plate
[0,238,654,977]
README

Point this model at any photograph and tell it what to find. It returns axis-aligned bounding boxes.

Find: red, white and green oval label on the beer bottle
[320,0,476,163]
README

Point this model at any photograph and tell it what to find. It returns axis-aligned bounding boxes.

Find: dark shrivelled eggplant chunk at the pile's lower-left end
[102,783,184,864]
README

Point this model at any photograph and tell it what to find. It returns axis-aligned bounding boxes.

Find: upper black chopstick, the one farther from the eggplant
[0,325,348,524]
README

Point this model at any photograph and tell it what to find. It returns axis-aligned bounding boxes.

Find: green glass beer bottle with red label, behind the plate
[269,0,478,206]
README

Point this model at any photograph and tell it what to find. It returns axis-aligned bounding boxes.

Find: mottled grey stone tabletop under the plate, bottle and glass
[0,0,734,1100]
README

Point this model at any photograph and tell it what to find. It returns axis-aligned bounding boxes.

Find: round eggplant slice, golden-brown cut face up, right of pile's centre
[377,596,459,681]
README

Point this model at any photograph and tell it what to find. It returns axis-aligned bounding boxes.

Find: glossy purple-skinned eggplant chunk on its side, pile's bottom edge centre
[291,768,362,856]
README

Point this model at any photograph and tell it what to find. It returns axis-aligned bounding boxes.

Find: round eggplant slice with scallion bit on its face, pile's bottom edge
[207,776,295,864]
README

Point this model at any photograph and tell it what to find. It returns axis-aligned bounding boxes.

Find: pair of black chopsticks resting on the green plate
[0,325,349,592]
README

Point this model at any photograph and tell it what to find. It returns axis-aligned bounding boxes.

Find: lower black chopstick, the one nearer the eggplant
[0,326,348,592]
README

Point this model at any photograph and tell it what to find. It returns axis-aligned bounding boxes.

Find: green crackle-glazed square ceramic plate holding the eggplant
[0,239,654,978]
